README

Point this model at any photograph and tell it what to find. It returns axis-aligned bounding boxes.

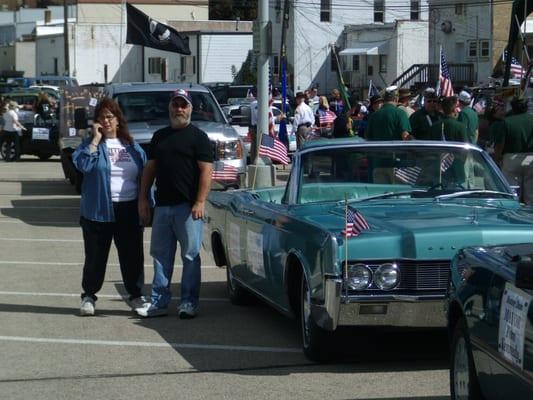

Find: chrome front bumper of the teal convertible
[311,278,446,331]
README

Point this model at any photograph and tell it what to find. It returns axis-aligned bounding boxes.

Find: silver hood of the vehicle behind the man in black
[128,120,239,143]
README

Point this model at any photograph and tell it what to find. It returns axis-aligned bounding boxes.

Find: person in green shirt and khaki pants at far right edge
[494,97,533,205]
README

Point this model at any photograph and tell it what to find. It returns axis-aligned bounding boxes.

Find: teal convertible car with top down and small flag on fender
[205,139,533,360]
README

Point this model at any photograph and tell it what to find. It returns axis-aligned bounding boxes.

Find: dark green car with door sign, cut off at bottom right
[447,242,533,400]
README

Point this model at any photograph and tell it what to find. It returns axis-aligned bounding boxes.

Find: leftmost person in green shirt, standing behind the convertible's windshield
[366,87,411,140]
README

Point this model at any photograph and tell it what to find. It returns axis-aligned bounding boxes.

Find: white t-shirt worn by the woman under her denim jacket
[105,139,139,202]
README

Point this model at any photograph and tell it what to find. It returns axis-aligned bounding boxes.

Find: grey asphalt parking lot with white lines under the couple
[0,157,449,400]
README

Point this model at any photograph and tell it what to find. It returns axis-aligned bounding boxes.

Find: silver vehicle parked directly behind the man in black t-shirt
[105,83,247,187]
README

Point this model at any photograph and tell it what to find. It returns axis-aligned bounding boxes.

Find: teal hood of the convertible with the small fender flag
[305,200,533,260]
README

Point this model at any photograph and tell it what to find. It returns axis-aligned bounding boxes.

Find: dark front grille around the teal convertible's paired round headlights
[348,260,450,294]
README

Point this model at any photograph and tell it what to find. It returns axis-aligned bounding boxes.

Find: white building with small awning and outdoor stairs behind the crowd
[270,0,428,93]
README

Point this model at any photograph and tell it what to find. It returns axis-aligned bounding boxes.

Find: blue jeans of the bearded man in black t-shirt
[150,204,204,308]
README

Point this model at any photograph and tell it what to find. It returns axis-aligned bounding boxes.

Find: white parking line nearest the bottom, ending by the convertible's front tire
[0,336,301,353]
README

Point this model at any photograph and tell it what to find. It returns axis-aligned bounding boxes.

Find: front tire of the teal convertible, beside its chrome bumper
[300,273,334,362]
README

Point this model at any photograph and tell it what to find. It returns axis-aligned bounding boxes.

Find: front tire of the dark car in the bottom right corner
[450,317,483,400]
